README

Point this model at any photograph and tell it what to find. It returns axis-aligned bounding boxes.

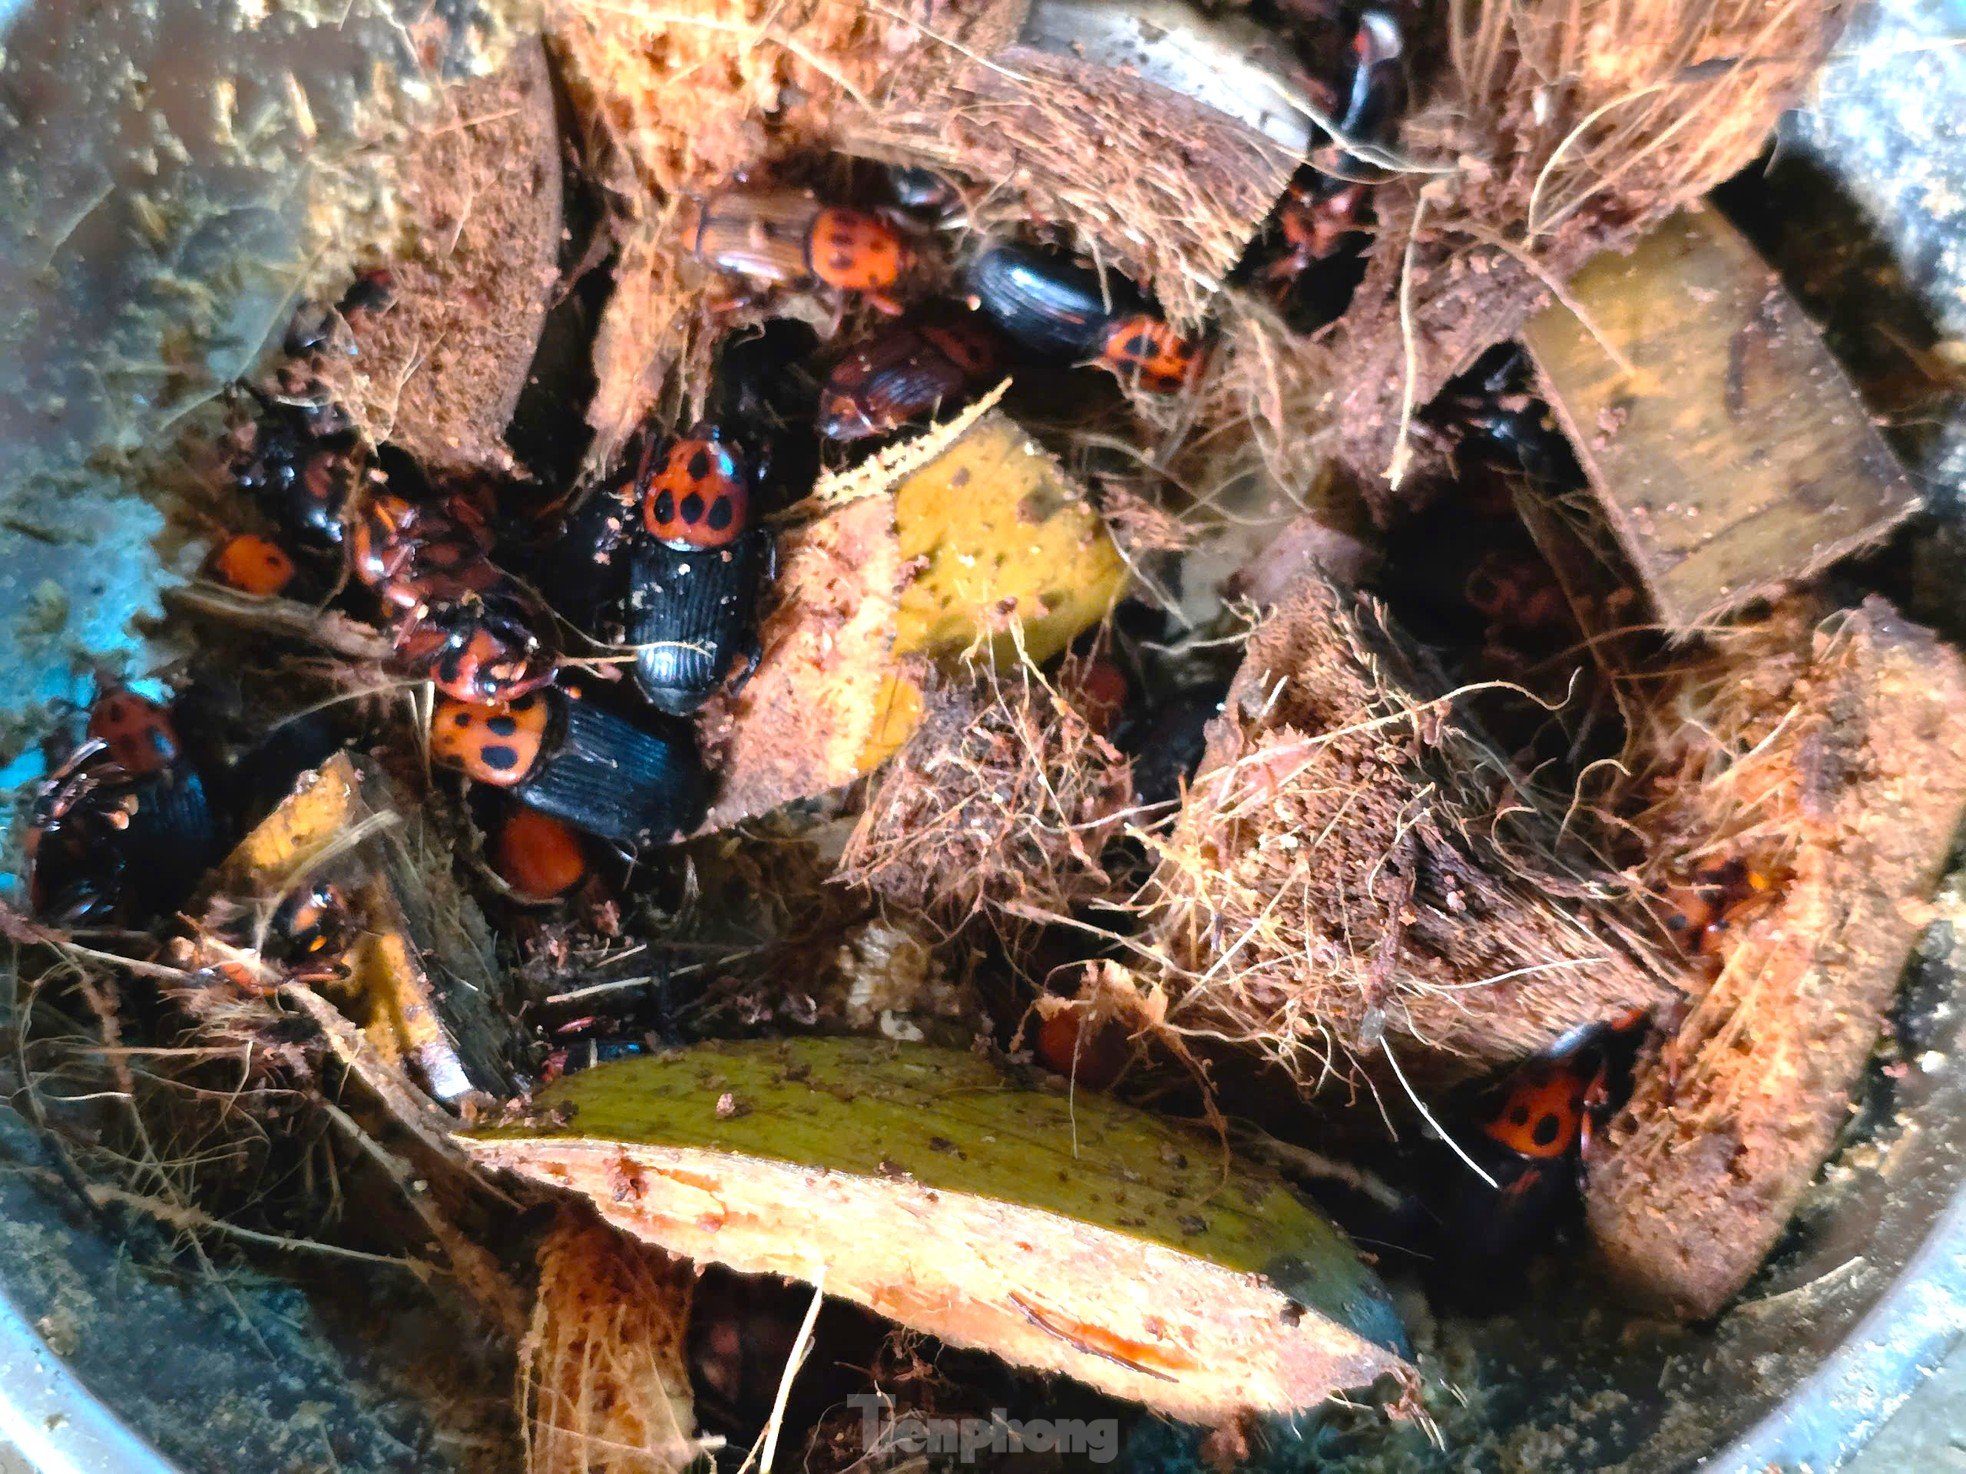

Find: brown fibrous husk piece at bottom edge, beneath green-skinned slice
[519,1211,710,1474]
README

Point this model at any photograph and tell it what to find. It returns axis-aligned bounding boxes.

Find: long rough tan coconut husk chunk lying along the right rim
[1585,597,1966,1319]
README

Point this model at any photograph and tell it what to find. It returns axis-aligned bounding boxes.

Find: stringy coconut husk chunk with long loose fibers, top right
[1205,0,1850,517]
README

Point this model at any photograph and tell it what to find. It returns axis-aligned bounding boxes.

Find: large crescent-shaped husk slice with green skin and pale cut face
[464,1040,1412,1423]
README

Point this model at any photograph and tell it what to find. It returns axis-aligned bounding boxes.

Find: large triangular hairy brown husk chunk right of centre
[1150,578,1671,1087]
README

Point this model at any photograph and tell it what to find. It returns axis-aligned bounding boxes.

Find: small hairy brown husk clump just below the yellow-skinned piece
[838,670,1132,922]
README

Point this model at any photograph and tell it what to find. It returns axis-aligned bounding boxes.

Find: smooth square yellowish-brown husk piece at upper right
[1524,210,1919,635]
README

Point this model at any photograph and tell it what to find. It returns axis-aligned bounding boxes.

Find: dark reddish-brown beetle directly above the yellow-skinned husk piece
[818,312,1006,440]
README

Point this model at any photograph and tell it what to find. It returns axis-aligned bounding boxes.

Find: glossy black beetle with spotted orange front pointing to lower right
[965,246,1201,393]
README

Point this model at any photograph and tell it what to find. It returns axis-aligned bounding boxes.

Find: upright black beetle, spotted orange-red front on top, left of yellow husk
[621,425,777,717]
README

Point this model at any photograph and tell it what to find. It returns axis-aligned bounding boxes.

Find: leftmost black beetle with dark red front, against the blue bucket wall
[26,686,220,924]
